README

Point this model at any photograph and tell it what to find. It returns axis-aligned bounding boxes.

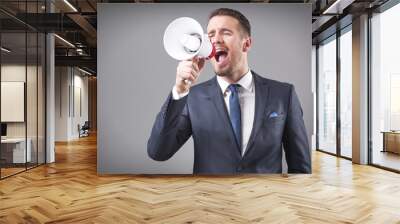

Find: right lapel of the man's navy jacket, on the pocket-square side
[243,71,269,157]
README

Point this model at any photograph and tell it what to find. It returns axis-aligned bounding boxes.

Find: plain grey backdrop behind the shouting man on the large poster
[97,3,313,174]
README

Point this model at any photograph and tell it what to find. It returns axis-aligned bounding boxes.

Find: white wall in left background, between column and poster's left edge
[55,67,88,141]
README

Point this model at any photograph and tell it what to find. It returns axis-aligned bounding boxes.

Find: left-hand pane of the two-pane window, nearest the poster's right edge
[318,38,336,156]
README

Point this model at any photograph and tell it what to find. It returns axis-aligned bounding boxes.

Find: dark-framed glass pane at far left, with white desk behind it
[0,32,27,178]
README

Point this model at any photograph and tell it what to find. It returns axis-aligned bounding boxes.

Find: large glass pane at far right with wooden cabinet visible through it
[371,4,400,170]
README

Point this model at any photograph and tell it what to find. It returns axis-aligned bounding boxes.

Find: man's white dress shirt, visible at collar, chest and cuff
[172,69,255,156]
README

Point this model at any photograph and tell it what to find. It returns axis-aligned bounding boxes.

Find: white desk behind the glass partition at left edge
[1,138,32,163]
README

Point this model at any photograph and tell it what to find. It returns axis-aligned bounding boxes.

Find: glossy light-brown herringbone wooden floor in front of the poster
[0,134,400,224]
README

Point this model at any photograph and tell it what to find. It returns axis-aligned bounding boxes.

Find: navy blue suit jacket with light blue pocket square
[147,72,311,174]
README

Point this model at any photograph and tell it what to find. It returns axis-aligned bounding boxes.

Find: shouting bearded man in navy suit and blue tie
[147,8,311,174]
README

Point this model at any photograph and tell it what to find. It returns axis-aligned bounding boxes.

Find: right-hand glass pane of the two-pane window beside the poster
[340,30,352,158]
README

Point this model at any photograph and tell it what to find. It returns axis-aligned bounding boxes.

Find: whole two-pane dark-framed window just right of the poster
[317,24,353,159]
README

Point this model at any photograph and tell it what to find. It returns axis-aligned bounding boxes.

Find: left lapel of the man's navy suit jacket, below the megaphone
[206,77,241,155]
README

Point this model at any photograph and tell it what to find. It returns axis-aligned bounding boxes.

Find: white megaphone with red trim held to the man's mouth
[164,17,215,61]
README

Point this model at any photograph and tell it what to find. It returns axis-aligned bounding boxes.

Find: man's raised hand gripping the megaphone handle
[175,57,205,94]
